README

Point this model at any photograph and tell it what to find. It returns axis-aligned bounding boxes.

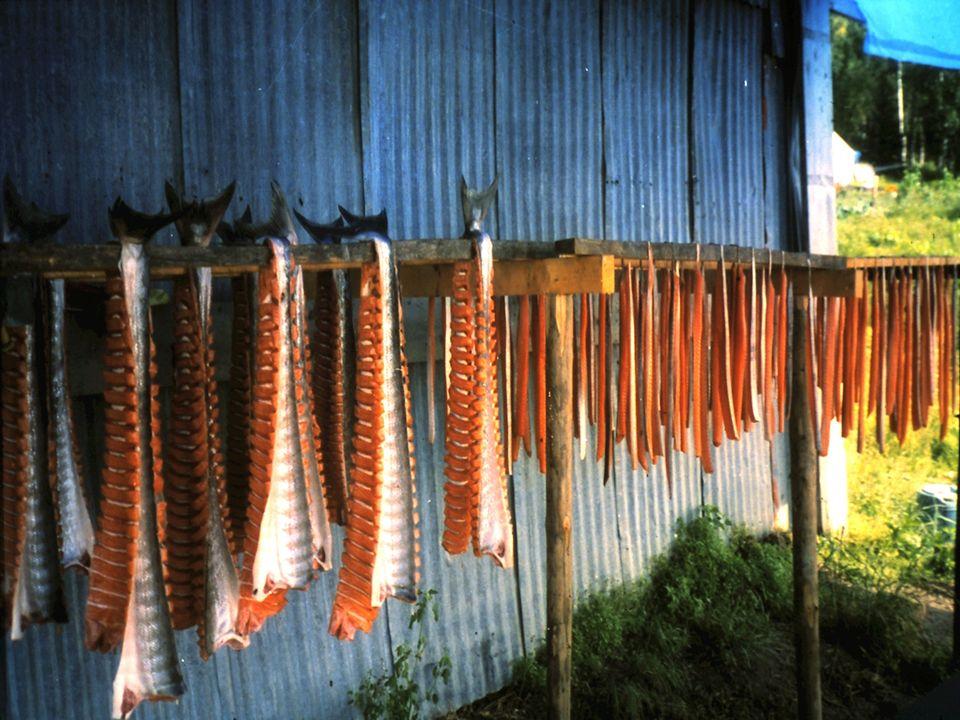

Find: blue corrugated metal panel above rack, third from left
[361,0,503,238]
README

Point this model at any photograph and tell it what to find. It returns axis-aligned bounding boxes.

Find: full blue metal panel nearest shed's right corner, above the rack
[692,0,764,247]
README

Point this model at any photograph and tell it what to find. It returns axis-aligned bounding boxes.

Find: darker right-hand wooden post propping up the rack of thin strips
[790,296,823,720]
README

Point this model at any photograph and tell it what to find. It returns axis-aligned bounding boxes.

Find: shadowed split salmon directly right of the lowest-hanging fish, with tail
[164,183,249,659]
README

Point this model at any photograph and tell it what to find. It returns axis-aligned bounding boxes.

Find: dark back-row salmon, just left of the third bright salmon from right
[217,205,259,557]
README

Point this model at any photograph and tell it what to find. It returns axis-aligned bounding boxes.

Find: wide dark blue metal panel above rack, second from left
[176,0,363,222]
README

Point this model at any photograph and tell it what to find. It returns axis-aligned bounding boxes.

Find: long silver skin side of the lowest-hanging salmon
[113,242,184,718]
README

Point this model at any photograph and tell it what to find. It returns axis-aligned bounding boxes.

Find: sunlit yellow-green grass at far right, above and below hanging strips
[836,173,960,593]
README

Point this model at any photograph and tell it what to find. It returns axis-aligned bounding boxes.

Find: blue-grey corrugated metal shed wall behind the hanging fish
[0,0,788,718]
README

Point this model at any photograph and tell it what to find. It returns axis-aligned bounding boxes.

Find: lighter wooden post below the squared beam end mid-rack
[545,295,573,720]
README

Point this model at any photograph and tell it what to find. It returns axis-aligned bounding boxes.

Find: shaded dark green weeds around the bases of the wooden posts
[457,510,947,720]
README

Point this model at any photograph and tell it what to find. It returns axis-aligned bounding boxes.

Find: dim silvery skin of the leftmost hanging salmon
[5,325,67,640]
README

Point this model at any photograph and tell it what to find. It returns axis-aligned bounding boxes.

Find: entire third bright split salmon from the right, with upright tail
[237,182,333,635]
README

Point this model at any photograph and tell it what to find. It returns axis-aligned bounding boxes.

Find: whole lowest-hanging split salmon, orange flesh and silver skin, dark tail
[86,198,184,717]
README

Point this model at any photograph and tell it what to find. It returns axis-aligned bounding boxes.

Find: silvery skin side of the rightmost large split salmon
[476,233,513,568]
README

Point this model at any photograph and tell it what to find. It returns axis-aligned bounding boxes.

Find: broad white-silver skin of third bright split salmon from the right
[253,238,313,599]
